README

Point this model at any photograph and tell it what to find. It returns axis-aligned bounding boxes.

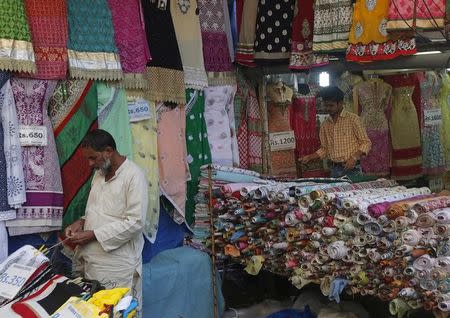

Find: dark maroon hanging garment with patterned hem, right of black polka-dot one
[289,0,329,70]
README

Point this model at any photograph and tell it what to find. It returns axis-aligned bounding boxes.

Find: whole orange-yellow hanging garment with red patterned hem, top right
[346,0,417,62]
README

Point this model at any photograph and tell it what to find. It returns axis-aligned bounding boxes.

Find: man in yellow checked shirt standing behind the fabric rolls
[300,86,372,178]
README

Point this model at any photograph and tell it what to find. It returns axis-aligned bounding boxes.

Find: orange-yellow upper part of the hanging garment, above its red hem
[349,0,389,44]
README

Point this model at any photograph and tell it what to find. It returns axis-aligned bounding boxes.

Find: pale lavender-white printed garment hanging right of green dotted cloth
[204,86,237,167]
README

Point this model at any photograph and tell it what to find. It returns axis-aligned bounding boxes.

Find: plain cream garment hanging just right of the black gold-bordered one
[170,1,208,89]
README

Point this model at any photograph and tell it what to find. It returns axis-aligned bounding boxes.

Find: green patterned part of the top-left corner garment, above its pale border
[0,0,31,42]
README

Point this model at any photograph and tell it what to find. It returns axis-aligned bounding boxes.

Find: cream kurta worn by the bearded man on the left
[75,159,148,304]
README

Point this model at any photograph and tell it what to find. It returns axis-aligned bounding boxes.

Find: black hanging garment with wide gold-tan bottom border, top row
[141,0,186,105]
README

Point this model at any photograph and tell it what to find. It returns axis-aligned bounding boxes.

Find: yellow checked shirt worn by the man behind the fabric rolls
[317,110,372,162]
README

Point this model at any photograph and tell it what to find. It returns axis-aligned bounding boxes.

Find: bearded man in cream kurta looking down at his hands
[65,129,148,304]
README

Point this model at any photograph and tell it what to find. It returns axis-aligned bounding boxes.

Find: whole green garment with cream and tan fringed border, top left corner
[0,0,36,73]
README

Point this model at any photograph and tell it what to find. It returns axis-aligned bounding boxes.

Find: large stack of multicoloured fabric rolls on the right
[194,167,450,317]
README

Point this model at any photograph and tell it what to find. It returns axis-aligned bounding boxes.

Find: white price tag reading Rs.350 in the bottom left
[0,264,36,299]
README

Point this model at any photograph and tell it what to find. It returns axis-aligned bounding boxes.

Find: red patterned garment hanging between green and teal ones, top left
[24,0,68,79]
